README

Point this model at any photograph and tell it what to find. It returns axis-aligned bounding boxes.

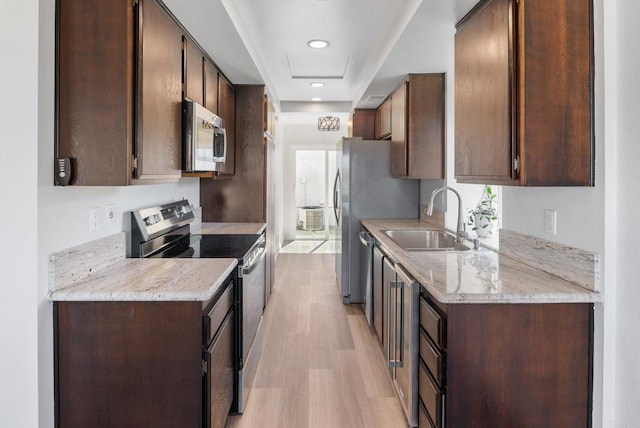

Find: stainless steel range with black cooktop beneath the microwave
[129,200,266,413]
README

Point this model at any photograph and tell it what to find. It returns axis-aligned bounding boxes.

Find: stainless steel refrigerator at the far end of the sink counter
[333,138,420,322]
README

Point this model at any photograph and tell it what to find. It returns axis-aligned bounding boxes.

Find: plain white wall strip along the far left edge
[0,0,38,427]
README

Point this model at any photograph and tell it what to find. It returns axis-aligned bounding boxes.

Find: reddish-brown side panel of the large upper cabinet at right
[517,0,594,186]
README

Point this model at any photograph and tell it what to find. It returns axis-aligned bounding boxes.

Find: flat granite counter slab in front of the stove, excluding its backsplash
[49,259,237,302]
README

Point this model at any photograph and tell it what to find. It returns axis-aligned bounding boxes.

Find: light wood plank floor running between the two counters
[227,254,407,428]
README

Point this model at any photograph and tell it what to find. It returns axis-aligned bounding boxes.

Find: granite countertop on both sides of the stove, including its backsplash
[49,223,266,301]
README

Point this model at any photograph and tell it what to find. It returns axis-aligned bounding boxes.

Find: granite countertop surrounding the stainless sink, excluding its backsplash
[362,219,602,303]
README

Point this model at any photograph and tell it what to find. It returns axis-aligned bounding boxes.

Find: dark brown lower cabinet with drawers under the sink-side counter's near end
[419,290,593,428]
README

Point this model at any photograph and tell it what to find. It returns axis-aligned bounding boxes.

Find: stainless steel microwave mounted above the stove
[182,100,227,172]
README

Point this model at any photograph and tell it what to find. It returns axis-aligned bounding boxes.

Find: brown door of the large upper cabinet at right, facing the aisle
[455,0,516,183]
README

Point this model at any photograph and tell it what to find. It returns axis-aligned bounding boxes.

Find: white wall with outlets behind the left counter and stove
[32,0,200,428]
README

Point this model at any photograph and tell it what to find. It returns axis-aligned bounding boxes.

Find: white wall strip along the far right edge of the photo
[607,0,640,428]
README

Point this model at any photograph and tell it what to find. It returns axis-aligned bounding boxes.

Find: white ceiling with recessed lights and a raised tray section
[164,0,478,112]
